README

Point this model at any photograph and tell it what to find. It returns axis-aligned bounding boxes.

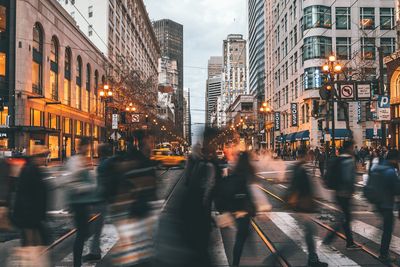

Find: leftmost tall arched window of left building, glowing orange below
[32,23,43,95]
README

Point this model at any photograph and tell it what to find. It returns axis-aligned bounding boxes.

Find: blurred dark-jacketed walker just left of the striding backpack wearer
[285,149,328,267]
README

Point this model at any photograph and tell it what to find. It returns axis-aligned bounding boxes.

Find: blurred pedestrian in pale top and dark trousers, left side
[66,138,96,267]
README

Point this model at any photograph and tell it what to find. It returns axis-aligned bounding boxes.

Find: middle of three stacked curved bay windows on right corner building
[303,36,332,60]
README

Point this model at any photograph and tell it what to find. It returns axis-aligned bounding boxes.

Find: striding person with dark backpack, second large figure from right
[323,141,360,250]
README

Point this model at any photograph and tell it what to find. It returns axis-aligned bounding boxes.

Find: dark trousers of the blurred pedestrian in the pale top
[72,204,89,267]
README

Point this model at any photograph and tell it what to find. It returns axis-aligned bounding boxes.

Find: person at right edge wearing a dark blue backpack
[364,150,400,265]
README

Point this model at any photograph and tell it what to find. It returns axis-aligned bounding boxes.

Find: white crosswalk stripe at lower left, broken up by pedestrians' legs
[56,224,119,267]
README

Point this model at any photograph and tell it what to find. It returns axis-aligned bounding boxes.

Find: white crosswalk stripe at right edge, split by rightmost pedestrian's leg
[351,220,400,253]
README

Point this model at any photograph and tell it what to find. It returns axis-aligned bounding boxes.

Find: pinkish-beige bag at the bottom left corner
[6,246,51,267]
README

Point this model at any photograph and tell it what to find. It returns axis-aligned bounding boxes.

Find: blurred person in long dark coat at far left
[12,145,50,246]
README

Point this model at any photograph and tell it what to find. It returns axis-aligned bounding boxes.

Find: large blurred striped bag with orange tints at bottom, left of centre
[111,214,156,266]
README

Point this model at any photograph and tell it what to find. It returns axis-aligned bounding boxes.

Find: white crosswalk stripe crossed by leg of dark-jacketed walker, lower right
[268,212,359,266]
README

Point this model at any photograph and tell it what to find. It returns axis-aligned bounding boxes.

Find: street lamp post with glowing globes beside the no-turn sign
[322,55,342,154]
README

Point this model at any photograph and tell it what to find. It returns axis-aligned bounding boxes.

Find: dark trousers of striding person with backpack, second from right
[325,196,354,246]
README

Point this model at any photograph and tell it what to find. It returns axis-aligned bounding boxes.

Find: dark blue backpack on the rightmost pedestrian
[363,165,388,205]
